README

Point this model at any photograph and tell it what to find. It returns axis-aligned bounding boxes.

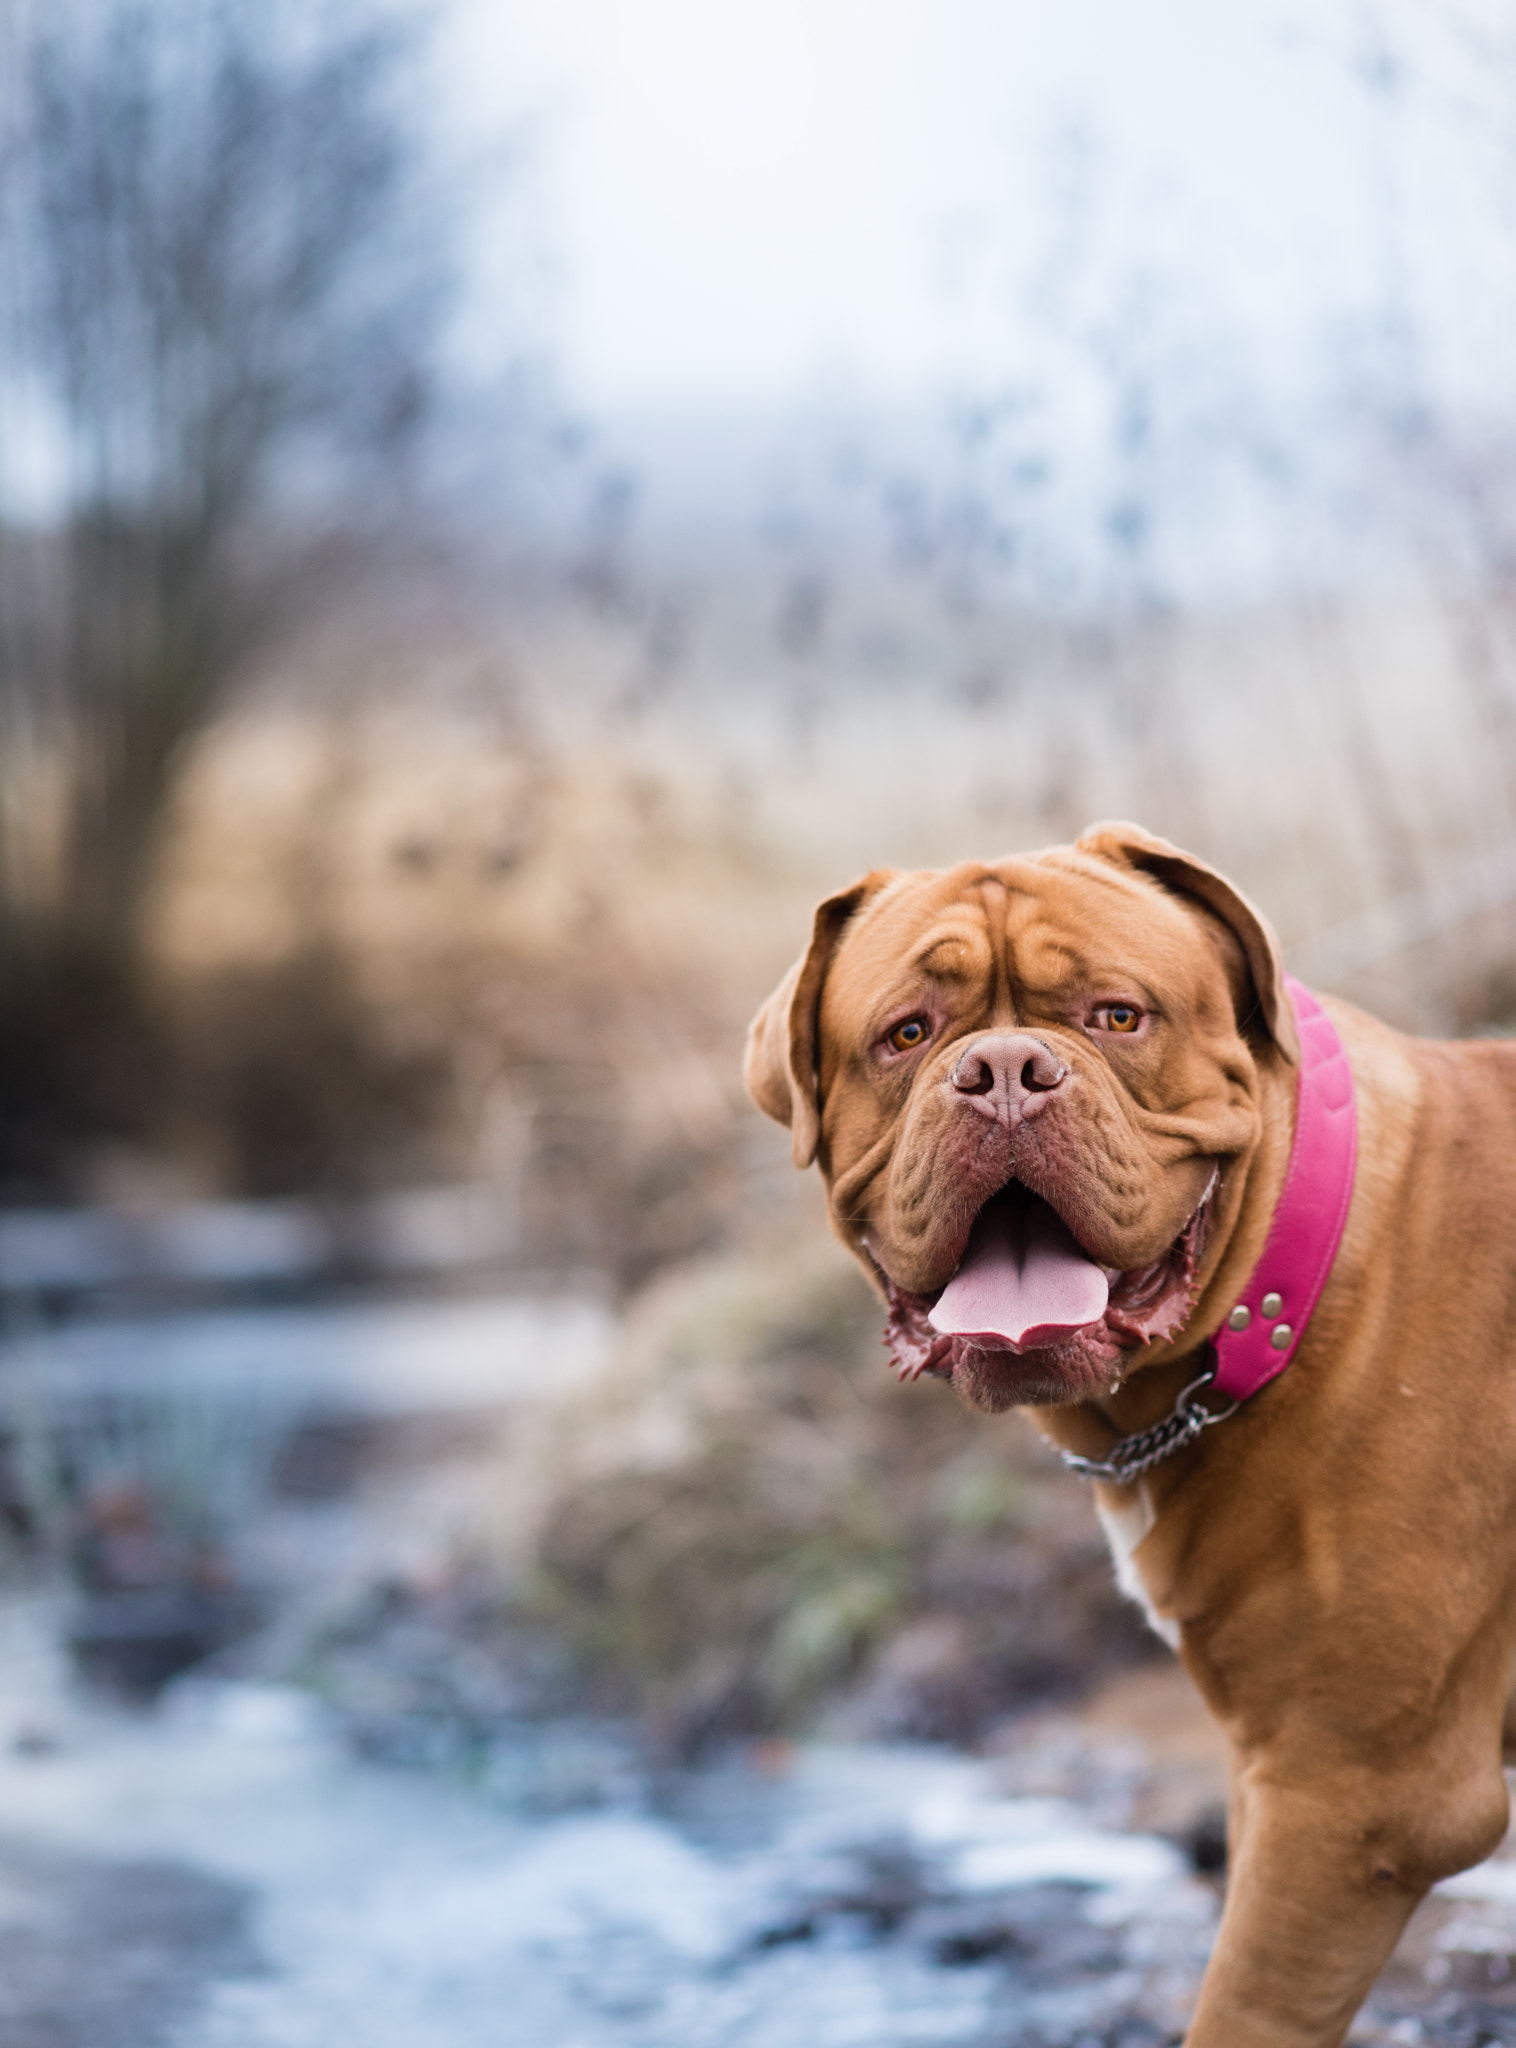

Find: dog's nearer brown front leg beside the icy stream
[1186,1745,1508,2048]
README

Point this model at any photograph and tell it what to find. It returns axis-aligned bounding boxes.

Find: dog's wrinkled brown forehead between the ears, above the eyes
[828,850,1219,1008]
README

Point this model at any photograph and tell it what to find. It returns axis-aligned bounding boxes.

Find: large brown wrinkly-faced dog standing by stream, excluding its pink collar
[748,825,1516,2048]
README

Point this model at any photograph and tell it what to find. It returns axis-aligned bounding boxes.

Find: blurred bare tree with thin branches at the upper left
[0,0,445,987]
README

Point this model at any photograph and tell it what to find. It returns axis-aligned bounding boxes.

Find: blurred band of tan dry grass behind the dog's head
[74,577,1516,1245]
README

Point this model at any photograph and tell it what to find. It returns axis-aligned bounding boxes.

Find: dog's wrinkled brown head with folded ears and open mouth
[748,825,1299,1409]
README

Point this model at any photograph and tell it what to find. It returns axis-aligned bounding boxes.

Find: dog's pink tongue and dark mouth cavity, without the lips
[928,1202,1110,1350]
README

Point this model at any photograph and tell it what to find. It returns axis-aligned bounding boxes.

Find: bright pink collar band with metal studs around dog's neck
[1211,975,1358,1401]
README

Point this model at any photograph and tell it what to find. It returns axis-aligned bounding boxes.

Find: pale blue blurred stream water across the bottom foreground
[0,1612,1215,2048]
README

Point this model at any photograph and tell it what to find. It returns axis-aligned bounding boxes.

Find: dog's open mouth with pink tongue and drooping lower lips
[885,1171,1219,1382]
